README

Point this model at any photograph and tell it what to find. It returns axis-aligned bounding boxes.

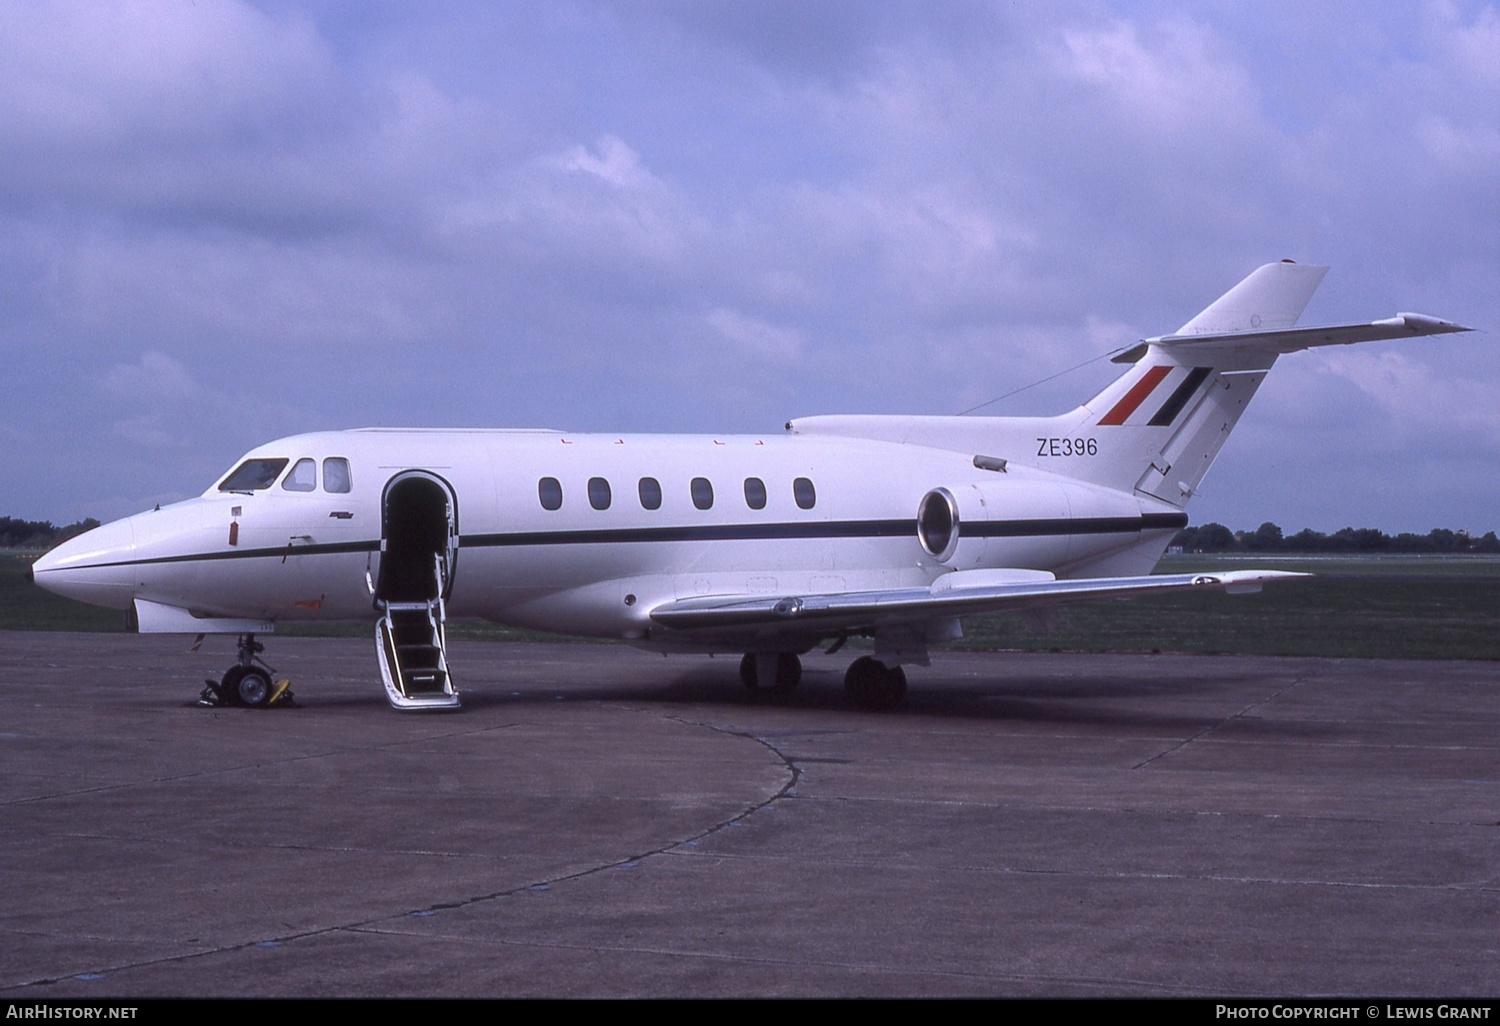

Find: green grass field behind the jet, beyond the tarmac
[11,552,1500,659]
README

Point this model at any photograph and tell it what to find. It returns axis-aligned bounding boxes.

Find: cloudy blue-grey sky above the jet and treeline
[0,0,1500,531]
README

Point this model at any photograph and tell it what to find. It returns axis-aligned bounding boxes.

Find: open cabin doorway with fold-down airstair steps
[375,471,459,710]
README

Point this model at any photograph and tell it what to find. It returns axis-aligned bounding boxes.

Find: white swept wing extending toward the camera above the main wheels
[651,570,1310,635]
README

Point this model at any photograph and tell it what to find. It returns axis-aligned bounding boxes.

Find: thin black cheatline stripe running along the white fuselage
[43,513,1188,570]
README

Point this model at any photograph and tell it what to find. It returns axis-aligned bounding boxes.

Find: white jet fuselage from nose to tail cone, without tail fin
[36,429,1185,648]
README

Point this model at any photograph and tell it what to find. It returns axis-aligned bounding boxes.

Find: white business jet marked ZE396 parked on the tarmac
[33,261,1469,710]
